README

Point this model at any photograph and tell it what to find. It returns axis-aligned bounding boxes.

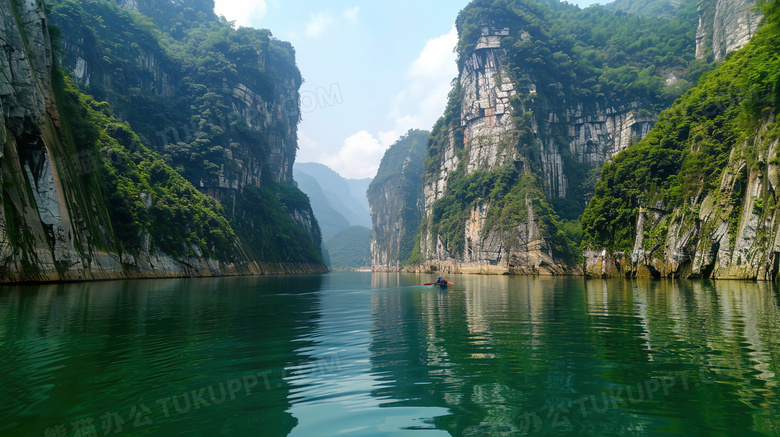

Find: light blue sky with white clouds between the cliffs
[216,0,606,178]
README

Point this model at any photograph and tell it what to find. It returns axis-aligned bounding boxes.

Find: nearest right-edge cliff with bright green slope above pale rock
[583,2,780,280]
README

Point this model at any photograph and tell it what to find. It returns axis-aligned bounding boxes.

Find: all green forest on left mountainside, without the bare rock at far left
[44,0,321,263]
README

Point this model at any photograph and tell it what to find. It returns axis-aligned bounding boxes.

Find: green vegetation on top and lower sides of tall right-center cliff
[415,0,711,265]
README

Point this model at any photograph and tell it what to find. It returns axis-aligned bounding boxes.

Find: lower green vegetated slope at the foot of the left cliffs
[53,70,321,262]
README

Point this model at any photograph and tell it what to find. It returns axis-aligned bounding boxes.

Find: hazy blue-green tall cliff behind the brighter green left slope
[52,0,321,255]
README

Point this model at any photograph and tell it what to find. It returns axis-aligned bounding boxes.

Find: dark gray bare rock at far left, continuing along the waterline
[0,0,326,282]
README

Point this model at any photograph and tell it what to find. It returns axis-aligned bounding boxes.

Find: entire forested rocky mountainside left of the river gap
[2,0,325,281]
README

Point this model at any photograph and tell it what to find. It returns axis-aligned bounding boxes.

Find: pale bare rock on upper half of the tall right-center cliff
[458,27,657,200]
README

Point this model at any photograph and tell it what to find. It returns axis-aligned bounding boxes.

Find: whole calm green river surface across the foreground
[0,273,780,437]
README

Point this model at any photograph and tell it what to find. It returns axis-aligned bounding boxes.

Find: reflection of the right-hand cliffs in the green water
[370,275,780,435]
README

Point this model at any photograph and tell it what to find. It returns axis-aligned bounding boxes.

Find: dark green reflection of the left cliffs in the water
[0,277,322,436]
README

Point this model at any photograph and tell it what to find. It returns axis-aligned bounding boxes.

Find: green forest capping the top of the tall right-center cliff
[458,0,708,109]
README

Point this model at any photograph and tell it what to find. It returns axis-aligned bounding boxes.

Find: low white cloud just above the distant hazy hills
[319,131,387,179]
